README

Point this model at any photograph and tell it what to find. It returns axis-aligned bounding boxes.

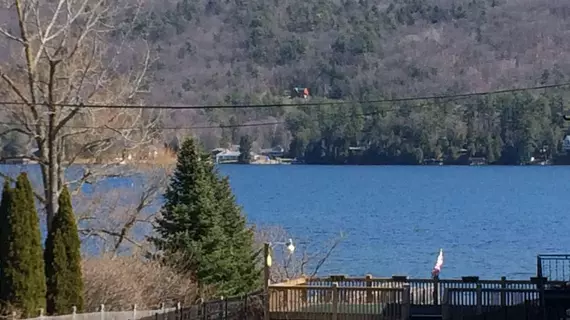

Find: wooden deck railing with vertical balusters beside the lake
[269,276,558,319]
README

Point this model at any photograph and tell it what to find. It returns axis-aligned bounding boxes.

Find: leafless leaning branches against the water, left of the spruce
[75,166,171,256]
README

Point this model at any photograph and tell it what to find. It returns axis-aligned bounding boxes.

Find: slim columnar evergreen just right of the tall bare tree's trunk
[44,187,83,314]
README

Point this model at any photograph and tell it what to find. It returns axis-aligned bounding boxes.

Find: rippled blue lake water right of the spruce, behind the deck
[216,165,570,279]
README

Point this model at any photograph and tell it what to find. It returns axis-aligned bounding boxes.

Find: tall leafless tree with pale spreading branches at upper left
[0,0,158,228]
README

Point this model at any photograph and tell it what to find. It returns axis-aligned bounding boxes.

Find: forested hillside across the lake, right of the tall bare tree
[1,0,570,163]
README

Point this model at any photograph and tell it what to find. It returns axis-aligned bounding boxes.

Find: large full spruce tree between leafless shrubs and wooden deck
[152,139,259,296]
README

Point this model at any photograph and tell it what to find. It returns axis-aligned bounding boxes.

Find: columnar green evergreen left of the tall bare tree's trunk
[2,173,46,317]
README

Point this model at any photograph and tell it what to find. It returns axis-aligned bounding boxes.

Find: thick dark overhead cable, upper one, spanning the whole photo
[0,82,570,110]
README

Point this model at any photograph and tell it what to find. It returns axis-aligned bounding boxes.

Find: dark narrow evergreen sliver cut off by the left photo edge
[0,180,12,315]
